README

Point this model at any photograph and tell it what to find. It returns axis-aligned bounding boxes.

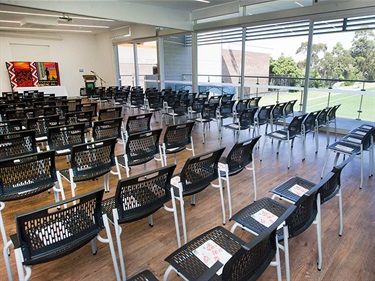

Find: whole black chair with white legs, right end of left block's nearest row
[218,136,261,218]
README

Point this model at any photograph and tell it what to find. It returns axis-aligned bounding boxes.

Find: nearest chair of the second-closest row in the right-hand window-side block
[223,107,258,142]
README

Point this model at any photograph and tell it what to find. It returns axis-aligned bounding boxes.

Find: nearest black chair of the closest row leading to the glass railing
[260,114,307,169]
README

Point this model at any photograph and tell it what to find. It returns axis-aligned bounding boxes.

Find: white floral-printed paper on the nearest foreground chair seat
[193,239,232,275]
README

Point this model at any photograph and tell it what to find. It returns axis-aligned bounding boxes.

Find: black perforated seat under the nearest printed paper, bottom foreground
[165,226,245,280]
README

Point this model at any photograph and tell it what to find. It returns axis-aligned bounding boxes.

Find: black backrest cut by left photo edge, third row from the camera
[0,130,37,159]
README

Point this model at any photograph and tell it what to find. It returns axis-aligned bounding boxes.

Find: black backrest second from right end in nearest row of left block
[180,147,225,194]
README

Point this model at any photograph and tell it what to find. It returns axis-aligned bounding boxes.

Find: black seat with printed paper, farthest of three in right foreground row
[270,177,315,202]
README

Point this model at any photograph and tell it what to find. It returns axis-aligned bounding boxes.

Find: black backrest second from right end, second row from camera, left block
[125,129,162,165]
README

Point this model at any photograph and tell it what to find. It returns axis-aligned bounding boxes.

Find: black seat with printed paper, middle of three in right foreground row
[232,197,288,234]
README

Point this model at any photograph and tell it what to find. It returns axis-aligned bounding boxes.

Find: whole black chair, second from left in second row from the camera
[57,138,121,196]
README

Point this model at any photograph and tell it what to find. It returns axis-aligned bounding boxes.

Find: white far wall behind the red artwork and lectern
[0,32,116,96]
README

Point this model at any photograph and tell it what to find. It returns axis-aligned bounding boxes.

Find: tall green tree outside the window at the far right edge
[350,30,375,80]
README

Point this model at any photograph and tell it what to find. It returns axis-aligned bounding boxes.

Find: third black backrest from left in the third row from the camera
[92,117,122,141]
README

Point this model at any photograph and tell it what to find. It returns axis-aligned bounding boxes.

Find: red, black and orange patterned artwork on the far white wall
[5,61,60,91]
